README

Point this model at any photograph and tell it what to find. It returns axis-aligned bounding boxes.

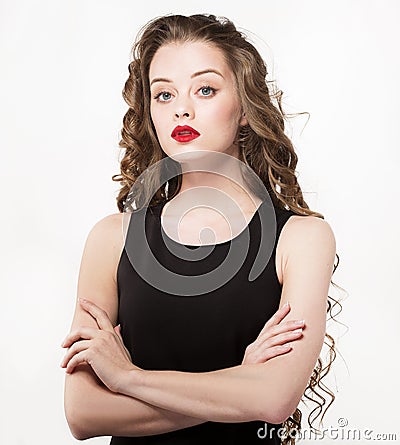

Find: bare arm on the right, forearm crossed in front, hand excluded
[111,217,336,423]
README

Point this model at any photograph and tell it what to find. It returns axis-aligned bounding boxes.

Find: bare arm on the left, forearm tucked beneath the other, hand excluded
[64,214,204,440]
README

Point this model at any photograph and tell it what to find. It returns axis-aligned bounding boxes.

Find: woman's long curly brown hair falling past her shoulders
[112,14,342,445]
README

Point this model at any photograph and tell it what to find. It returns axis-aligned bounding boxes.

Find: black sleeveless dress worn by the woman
[110,200,295,445]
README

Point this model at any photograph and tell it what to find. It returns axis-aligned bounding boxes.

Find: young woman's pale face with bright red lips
[149,42,246,157]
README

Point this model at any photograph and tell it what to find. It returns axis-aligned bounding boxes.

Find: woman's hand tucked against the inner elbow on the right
[242,303,304,365]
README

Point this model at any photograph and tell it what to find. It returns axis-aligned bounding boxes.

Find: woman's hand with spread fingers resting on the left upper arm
[61,299,140,392]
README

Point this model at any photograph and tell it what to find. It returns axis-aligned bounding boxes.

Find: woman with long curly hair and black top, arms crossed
[61,15,336,444]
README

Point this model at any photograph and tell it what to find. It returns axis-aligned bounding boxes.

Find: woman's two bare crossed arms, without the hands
[64,214,336,439]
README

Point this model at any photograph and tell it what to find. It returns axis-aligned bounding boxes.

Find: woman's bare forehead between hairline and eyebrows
[149,42,233,79]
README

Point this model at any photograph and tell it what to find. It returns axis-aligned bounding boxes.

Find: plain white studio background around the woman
[0,0,400,445]
